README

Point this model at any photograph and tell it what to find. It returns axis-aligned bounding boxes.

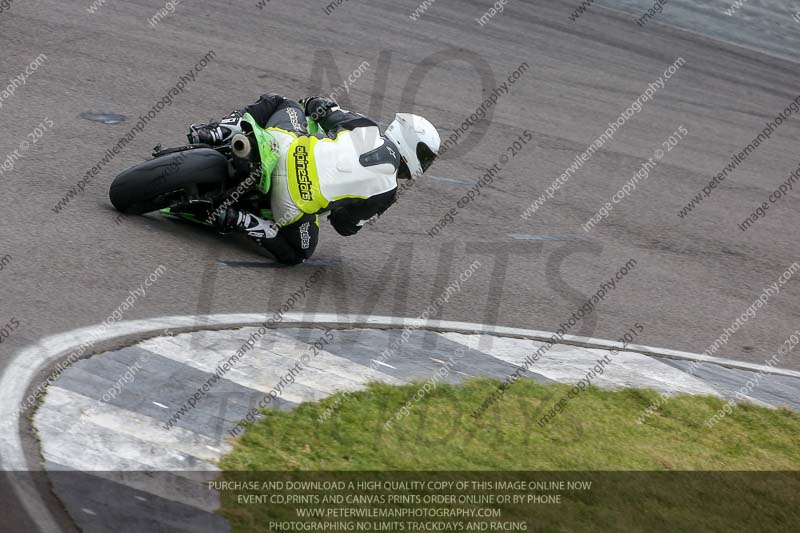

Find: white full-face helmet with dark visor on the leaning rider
[384,113,442,178]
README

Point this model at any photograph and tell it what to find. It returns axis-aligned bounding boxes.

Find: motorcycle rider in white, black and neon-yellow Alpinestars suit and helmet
[188,94,440,264]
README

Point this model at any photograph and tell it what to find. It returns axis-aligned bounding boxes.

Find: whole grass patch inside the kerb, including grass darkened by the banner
[220,380,800,532]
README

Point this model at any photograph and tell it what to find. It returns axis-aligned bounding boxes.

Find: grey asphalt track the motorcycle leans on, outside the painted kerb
[0,0,800,528]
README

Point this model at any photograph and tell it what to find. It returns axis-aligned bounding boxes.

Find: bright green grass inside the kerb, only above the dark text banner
[221,380,800,471]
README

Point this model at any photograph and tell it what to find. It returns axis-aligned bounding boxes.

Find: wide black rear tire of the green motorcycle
[108,148,228,215]
